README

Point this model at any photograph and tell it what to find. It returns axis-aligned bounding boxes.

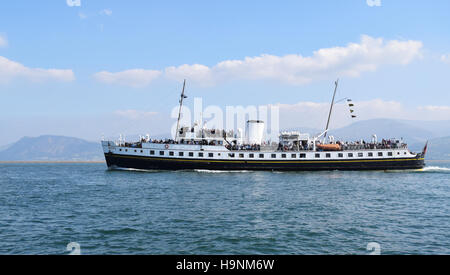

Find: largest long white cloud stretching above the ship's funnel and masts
[93,35,422,86]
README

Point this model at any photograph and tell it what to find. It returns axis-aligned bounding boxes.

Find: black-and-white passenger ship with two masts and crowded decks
[102,82,427,171]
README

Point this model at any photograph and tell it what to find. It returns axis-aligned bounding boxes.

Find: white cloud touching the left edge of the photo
[0,56,75,83]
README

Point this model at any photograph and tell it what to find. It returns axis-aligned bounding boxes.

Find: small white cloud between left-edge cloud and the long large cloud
[94,69,161,88]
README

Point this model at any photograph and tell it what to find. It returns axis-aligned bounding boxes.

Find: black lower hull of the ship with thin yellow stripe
[105,153,425,171]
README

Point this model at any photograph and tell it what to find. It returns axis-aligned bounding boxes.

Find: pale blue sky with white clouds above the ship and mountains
[0,0,450,145]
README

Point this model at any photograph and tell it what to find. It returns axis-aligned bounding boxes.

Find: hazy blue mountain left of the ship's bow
[0,135,103,161]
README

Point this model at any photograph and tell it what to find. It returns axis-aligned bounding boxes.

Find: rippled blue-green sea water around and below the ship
[0,162,450,254]
